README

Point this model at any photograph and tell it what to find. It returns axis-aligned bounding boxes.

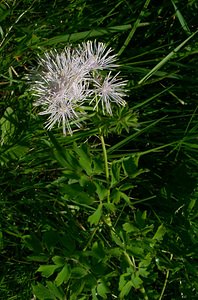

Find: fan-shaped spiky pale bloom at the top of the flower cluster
[77,40,118,72]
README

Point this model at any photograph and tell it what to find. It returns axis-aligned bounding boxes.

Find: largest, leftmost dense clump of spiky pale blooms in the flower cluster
[31,48,89,134]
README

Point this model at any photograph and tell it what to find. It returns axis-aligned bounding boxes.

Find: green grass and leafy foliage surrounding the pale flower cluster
[0,0,198,300]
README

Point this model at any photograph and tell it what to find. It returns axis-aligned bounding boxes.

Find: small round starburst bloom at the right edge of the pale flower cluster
[90,72,127,115]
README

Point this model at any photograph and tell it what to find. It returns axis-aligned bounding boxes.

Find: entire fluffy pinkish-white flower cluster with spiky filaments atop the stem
[30,41,127,134]
